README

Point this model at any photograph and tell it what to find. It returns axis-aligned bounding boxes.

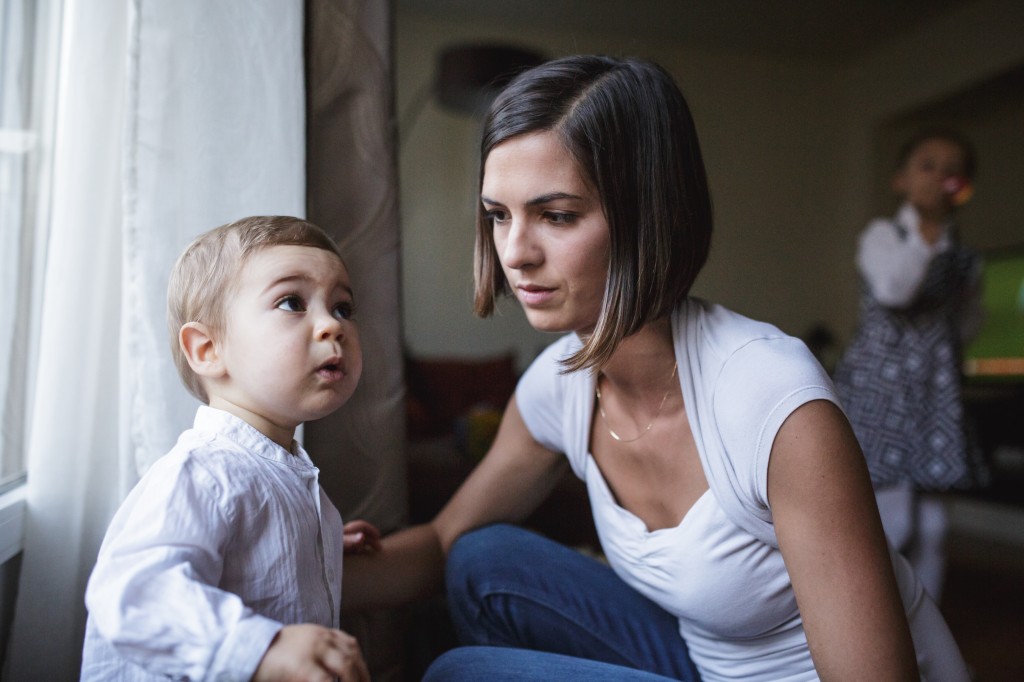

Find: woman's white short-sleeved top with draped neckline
[516,299,967,682]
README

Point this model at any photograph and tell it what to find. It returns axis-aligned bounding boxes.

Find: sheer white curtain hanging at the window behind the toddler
[5,0,305,682]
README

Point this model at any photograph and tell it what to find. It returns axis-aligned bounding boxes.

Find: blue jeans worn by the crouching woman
[425,525,699,682]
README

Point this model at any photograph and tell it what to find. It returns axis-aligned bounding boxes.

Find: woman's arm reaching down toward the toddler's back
[342,396,567,611]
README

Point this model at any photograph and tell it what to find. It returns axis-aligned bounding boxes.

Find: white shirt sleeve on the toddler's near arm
[85,450,282,680]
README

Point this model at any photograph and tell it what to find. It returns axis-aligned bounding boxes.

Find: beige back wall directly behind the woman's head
[396,7,846,367]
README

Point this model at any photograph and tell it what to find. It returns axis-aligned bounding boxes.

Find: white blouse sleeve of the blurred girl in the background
[857,219,942,308]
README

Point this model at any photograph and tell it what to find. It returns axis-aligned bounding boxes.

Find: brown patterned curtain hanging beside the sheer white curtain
[305,0,408,671]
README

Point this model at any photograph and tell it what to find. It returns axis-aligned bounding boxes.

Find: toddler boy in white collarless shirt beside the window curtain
[82,216,379,681]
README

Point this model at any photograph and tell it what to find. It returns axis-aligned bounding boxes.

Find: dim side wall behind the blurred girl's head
[841,0,1024,268]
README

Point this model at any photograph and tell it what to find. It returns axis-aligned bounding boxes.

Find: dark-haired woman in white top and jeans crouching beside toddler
[345,56,967,680]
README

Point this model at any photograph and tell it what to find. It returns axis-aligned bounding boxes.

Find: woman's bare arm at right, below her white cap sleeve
[768,400,919,681]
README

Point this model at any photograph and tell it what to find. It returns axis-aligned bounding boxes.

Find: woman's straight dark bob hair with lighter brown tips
[474,55,712,371]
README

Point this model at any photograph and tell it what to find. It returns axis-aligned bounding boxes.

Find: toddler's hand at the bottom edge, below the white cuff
[253,625,370,682]
